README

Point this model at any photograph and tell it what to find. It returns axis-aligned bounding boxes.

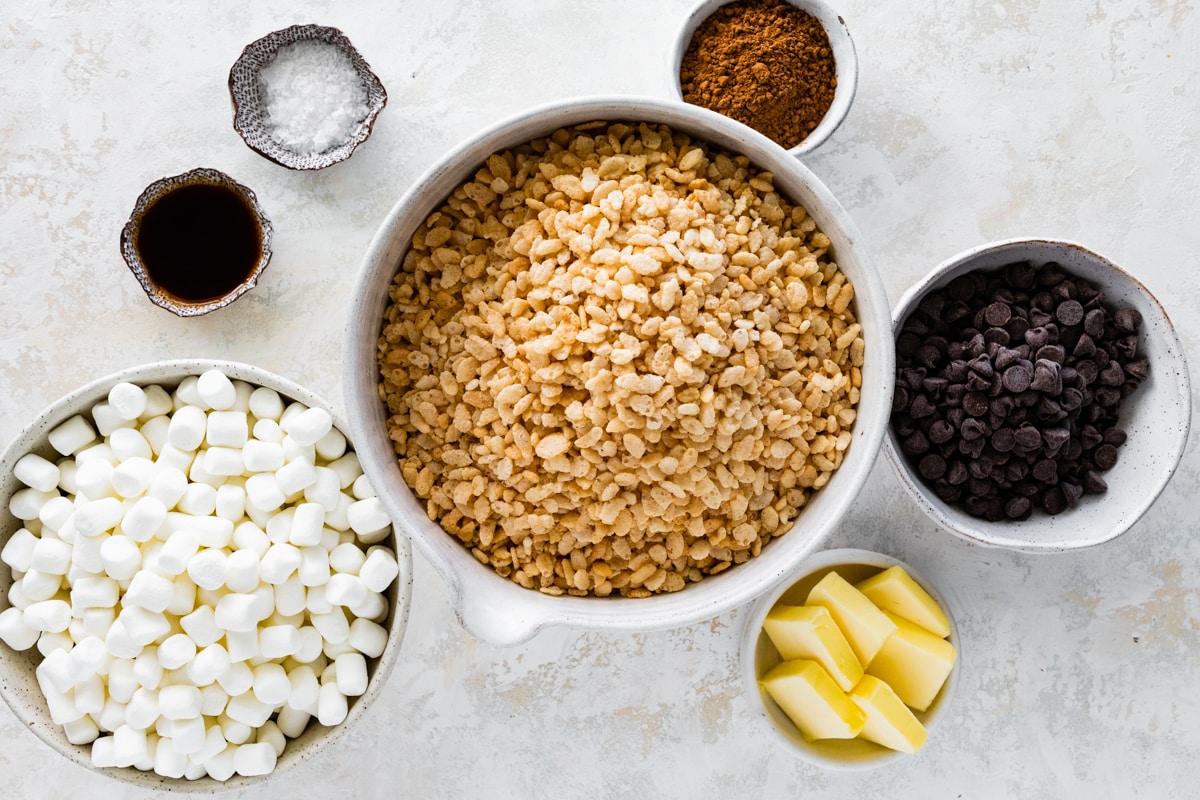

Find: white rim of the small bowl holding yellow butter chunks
[738,547,964,771]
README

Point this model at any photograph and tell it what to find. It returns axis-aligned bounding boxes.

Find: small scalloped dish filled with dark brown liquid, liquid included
[121,167,272,317]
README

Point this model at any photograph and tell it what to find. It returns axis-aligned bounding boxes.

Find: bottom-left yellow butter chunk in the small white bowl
[760,658,866,741]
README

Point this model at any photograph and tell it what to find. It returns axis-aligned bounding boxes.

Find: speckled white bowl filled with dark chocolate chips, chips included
[884,239,1192,552]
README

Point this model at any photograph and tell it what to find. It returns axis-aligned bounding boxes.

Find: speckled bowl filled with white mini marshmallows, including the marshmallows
[0,360,412,792]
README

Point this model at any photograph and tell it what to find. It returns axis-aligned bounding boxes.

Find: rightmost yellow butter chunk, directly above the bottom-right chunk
[866,614,958,711]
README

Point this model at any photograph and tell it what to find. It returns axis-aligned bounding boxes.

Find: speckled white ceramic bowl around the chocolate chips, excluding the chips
[884,239,1192,553]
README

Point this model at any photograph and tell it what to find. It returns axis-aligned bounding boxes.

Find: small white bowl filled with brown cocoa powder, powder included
[672,0,858,156]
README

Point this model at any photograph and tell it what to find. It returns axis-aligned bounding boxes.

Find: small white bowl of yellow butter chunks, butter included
[742,549,959,770]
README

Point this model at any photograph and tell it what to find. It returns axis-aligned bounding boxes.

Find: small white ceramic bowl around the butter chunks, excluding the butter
[740,548,962,770]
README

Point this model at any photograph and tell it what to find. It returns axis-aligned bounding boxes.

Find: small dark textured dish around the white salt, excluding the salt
[229,25,388,169]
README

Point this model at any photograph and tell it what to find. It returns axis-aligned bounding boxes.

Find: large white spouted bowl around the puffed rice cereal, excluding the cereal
[343,97,895,644]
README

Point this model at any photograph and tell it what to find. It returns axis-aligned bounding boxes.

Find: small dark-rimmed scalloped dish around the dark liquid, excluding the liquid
[121,167,271,317]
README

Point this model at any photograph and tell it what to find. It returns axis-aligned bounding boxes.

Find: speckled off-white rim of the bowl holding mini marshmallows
[0,359,413,794]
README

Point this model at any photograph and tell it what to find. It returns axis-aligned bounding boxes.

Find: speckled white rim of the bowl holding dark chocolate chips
[883,236,1192,553]
